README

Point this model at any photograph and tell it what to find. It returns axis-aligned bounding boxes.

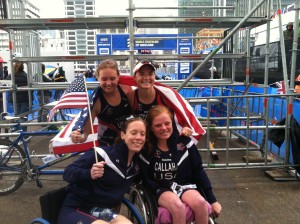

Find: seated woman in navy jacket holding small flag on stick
[57,118,146,224]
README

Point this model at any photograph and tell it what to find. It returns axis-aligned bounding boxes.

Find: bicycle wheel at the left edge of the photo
[0,139,26,196]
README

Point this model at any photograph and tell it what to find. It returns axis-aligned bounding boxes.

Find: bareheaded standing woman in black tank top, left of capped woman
[71,60,133,145]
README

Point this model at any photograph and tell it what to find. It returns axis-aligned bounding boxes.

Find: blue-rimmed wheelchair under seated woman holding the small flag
[31,187,145,224]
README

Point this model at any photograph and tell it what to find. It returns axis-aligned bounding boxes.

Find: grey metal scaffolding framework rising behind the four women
[0,0,299,178]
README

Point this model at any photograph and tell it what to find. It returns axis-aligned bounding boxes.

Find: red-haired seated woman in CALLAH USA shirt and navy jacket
[139,105,222,224]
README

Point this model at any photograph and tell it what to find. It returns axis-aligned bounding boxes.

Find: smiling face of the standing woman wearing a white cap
[134,65,155,89]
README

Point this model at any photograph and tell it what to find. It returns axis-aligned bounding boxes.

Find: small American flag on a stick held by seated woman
[48,77,88,121]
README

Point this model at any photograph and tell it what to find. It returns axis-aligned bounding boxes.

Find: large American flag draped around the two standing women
[50,76,205,154]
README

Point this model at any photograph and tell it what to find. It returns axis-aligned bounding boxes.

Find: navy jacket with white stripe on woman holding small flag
[63,143,139,210]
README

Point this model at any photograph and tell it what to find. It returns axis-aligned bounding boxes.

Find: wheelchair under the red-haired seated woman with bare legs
[128,182,216,224]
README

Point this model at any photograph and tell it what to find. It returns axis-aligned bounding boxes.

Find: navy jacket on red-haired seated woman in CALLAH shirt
[139,135,216,204]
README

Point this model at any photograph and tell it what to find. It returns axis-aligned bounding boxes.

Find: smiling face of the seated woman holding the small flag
[121,118,146,153]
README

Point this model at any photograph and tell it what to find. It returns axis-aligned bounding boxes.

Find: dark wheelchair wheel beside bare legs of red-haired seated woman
[128,184,157,224]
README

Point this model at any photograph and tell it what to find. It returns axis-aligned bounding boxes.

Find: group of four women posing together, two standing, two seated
[64,60,221,224]
